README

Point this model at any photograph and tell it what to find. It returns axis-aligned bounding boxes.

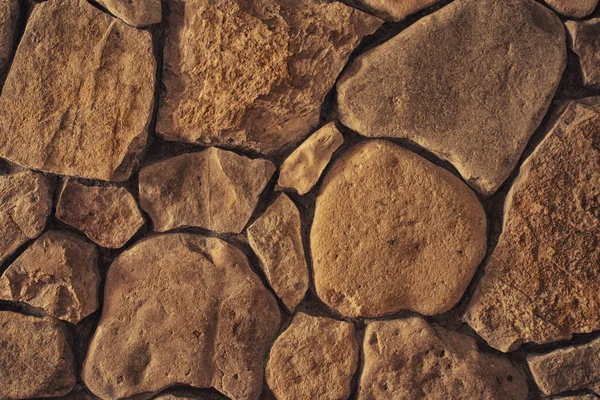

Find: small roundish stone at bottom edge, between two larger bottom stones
[266,313,358,400]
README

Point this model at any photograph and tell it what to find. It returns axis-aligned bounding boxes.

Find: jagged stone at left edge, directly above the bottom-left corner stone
[0,231,100,324]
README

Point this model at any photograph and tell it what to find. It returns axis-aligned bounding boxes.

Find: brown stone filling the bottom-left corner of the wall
[0,311,77,400]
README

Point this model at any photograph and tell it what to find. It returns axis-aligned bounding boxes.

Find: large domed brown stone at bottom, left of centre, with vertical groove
[82,234,280,400]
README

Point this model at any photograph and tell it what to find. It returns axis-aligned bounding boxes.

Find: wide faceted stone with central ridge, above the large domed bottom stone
[139,147,275,233]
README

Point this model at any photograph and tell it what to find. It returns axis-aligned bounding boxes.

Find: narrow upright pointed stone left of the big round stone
[248,194,309,312]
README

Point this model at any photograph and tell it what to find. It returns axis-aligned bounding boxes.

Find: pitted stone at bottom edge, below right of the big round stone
[358,317,528,400]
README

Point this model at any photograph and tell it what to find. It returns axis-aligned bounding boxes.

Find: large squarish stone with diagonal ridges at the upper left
[0,0,156,180]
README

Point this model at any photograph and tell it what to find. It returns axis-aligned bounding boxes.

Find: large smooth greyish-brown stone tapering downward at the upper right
[337,0,566,195]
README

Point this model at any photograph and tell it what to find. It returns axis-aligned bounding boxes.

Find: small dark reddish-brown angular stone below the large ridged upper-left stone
[56,179,145,249]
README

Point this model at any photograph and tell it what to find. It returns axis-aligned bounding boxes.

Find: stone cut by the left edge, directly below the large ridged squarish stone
[0,171,52,263]
